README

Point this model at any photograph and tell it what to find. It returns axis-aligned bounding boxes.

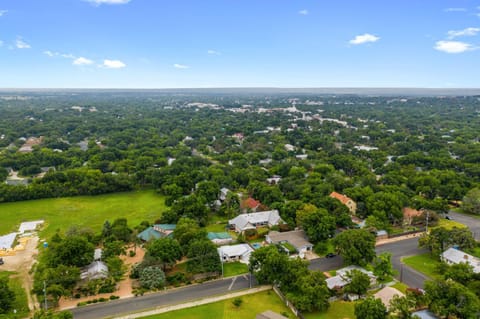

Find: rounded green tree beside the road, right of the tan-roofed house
[333,229,375,266]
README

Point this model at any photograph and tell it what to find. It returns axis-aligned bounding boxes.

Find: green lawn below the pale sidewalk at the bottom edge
[144,290,295,319]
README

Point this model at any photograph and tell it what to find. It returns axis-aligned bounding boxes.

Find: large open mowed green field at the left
[0,190,166,238]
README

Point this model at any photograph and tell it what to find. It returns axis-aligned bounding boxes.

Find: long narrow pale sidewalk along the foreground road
[110,286,272,319]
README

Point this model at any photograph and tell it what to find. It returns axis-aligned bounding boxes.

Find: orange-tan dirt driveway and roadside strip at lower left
[58,247,145,310]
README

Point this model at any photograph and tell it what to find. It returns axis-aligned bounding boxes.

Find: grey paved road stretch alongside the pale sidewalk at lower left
[71,275,256,319]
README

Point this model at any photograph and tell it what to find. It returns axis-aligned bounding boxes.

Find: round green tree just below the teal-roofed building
[146,237,182,271]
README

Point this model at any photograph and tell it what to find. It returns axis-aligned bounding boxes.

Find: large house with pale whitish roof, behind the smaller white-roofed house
[228,209,283,233]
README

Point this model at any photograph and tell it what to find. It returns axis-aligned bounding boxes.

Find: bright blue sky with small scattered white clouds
[0,0,480,88]
